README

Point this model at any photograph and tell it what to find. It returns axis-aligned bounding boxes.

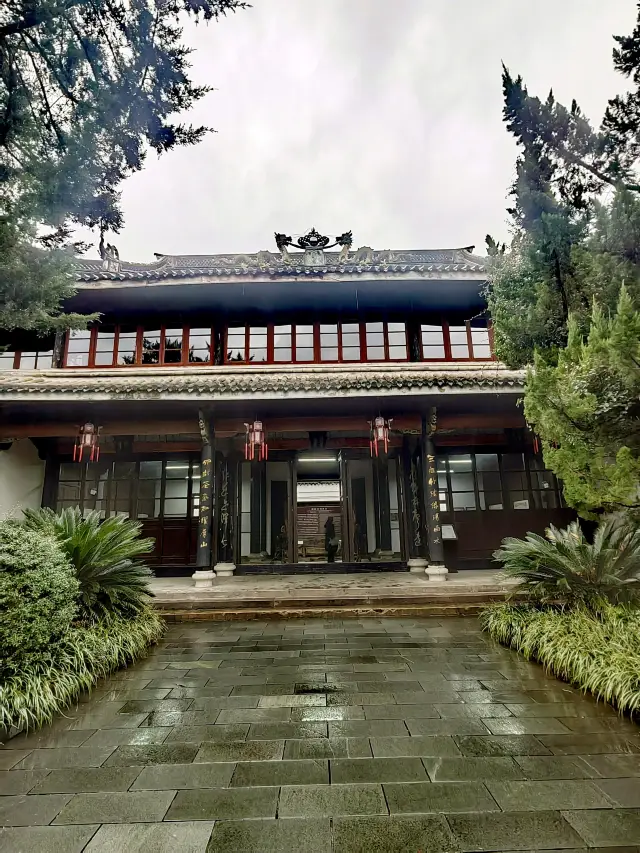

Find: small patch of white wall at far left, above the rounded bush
[0,438,44,520]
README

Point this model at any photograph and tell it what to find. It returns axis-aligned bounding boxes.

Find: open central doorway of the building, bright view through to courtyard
[296,451,345,563]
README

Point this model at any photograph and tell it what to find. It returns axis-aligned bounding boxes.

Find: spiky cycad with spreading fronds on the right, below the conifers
[493,518,640,609]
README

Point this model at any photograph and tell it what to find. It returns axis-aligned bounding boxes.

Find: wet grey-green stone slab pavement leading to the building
[0,618,640,853]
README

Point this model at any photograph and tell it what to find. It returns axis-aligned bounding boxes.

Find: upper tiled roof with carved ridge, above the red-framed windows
[76,247,486,282]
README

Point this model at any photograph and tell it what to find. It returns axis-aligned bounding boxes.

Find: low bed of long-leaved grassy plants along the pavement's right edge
[480,604,640,713]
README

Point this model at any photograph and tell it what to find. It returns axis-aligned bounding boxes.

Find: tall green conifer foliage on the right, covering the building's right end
[487,5,640,516]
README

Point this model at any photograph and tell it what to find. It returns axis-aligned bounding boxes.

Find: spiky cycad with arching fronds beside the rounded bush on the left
[24,507,154,620]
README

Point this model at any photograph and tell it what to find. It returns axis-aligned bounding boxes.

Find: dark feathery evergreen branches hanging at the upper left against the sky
[0,0,246,328]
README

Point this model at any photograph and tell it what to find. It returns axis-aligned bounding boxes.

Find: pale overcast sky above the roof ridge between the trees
[99,0,636,261]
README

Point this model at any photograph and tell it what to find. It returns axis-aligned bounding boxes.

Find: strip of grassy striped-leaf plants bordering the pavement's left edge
[0,607,164,729]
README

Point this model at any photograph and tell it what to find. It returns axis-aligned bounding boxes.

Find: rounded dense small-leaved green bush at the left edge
[0,521,79,674]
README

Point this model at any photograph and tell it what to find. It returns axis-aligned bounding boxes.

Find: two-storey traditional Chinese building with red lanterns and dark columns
[0,230,571,580]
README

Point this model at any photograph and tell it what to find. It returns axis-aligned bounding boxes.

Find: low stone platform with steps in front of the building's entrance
[151,571,513,620]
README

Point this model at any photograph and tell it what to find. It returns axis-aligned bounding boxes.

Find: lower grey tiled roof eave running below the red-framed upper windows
[0,363,525,401]
